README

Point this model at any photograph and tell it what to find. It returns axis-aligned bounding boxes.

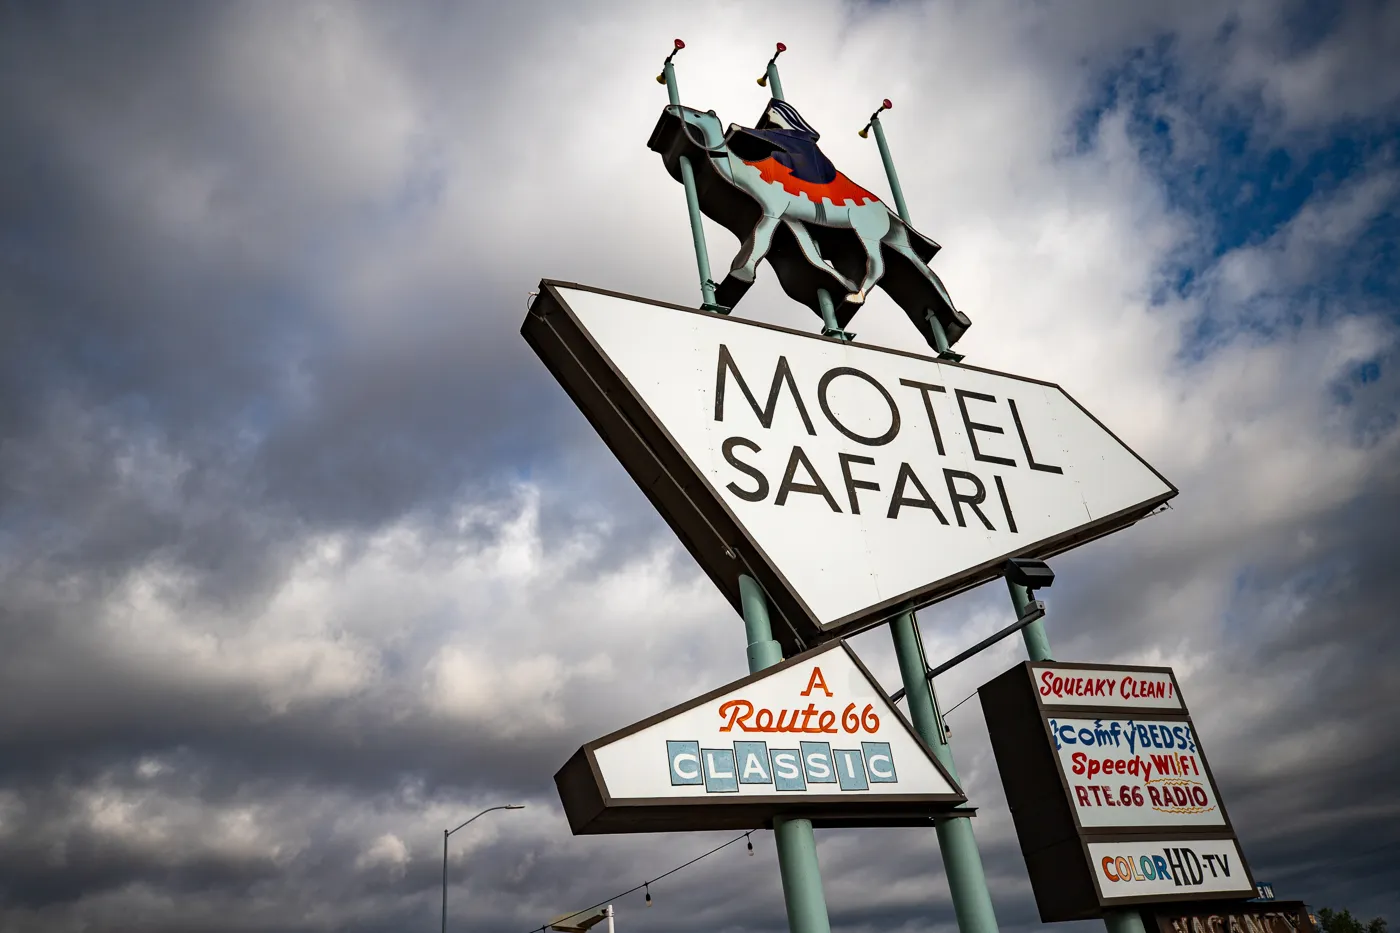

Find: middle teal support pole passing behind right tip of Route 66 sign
[889,612,997,933]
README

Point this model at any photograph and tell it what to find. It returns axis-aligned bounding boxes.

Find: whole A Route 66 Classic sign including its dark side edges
[554,640,966,834]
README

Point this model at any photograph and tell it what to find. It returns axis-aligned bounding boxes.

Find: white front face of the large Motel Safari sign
[559,287,1176,628]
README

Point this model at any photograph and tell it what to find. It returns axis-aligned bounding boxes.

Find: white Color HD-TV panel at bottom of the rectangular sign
[1088,839,1254,901]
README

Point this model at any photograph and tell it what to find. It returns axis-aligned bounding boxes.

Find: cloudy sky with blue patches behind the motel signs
[0,0,1400,933]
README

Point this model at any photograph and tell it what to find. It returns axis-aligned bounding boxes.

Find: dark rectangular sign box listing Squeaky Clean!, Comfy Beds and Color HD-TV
[979,661,1253,922]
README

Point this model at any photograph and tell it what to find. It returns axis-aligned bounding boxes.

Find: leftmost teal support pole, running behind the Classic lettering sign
[739,574,832,933]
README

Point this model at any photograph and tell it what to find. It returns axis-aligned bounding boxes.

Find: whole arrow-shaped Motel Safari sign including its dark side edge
[522,282,1176,650]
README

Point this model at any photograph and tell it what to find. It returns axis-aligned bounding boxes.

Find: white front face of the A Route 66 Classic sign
[594,638,962,800]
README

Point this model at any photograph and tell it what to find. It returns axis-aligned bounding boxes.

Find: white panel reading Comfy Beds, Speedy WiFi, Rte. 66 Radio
[1050,719,1225,829]
